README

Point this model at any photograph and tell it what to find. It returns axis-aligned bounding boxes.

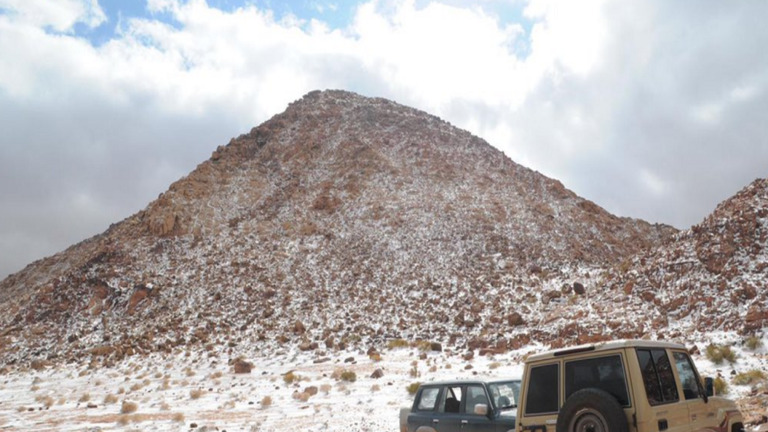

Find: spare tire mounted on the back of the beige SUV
[556,388,629,432]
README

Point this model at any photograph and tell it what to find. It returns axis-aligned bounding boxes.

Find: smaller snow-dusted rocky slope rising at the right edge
[610,179,768,335]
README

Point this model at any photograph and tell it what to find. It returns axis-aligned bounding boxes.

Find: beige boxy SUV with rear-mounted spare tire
[517,340,744,432]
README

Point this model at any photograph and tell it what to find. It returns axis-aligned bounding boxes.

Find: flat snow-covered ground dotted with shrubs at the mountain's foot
[0,333,768,432]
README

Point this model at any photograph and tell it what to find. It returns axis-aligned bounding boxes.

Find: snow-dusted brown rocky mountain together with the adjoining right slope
[0,91,768,428]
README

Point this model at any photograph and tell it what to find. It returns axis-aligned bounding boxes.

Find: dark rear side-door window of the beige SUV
[637,349,680,405]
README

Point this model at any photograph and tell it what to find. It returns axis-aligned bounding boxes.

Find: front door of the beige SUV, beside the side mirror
[672,351,719,431]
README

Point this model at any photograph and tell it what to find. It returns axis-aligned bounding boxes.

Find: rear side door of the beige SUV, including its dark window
[637,348,690,432]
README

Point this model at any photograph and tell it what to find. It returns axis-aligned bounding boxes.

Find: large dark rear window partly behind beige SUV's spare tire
[565,355,629,406]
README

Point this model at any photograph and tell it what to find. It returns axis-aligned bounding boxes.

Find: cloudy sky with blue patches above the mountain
[0,0,768,279]
